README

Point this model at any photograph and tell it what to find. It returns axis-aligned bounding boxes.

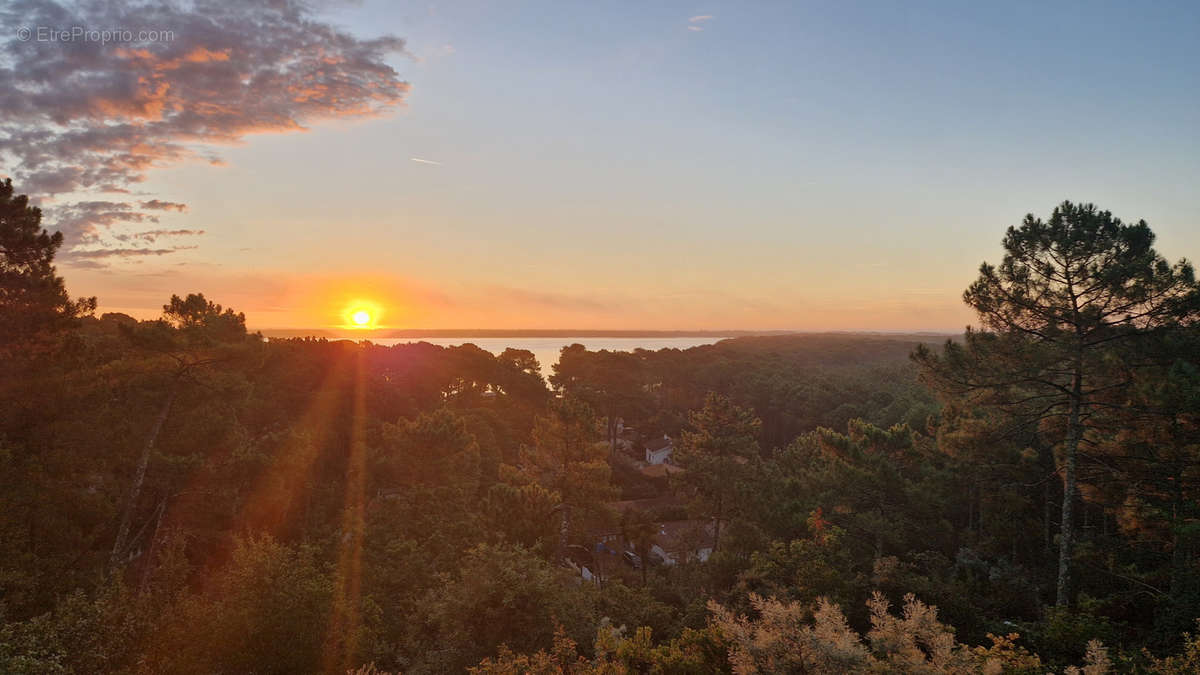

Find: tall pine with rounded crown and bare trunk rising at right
[914,202,1200,605]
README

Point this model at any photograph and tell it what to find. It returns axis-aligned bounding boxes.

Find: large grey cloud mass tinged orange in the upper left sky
[0,0,409,255]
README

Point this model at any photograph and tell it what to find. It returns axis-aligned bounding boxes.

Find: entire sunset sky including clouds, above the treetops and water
[0,0,1200,330]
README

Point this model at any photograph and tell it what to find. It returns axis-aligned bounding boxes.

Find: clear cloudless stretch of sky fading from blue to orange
[18,1,1200,329]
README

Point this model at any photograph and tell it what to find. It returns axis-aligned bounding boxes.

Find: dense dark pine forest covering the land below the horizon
[7,176,1200,674]
